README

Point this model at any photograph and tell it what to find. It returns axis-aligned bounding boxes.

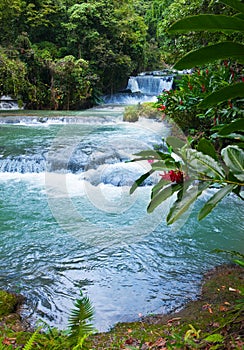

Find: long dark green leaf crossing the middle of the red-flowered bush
[198,83,244,108]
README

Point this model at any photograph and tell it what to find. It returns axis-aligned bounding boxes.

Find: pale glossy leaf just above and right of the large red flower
[187,149,225,179]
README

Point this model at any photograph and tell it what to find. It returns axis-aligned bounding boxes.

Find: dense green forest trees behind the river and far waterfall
[0,0,239,109]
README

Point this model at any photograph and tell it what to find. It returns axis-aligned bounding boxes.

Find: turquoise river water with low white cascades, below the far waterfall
[0,109,244,330]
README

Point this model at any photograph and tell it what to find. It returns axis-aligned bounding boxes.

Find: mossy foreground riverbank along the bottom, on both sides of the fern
[0,265,244,350]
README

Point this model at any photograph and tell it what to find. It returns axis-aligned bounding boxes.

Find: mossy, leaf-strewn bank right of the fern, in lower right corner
[89,265,244,350]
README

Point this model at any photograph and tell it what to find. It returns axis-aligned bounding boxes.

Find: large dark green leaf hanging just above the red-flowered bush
[174,42,244,69]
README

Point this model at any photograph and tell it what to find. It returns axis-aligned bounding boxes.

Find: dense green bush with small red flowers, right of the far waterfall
[156,61,243,137]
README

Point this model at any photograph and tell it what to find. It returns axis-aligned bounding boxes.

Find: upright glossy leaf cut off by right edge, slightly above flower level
[221,146,244,180]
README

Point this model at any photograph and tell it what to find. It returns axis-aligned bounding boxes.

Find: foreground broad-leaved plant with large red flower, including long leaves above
[130,0,244,224]
